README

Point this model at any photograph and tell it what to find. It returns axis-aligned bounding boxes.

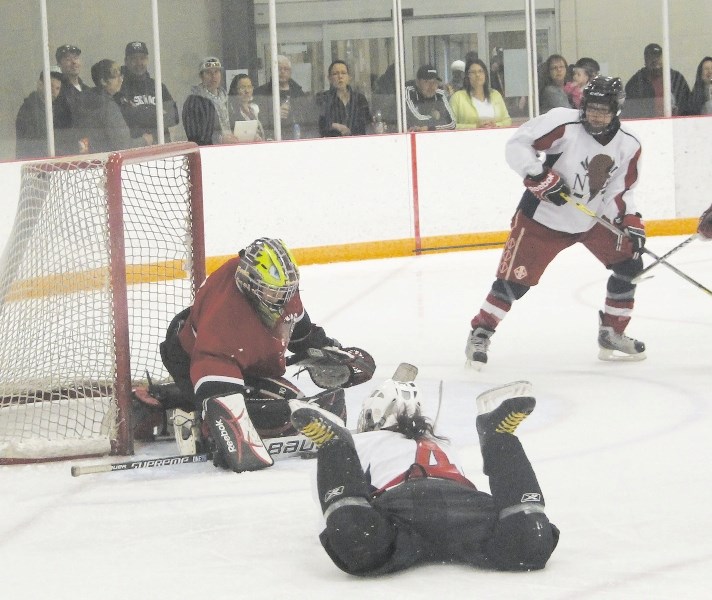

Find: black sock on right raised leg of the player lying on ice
[482,433,544,511]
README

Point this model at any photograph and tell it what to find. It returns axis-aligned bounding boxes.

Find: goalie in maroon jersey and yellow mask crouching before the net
[156,238,375,472]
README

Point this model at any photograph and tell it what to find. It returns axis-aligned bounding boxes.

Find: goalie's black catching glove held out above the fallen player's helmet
[287,347,376,389]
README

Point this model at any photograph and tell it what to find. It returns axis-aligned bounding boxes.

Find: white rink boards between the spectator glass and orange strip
[0,117,712,256]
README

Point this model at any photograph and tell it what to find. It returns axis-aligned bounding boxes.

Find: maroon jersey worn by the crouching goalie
[179,258,304,389]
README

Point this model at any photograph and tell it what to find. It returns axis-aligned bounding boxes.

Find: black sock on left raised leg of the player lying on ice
[317,440,369,512]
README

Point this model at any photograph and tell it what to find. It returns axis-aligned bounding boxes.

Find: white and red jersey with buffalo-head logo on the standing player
[505,108,641,233]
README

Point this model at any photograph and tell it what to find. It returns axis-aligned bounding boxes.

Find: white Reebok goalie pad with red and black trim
[203,394,274,473]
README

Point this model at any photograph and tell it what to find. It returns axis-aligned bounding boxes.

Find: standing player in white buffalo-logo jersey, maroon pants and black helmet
[465,75,645,369]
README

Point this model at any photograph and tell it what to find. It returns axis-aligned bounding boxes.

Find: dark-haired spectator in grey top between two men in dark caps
[81,58,153,153]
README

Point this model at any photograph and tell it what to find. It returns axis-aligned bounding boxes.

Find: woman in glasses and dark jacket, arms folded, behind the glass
[317,60,371,137]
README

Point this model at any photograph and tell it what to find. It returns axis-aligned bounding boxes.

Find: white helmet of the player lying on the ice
[357,379,420,433]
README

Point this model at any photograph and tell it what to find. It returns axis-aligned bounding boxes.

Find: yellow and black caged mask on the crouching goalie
[235,238,299,326]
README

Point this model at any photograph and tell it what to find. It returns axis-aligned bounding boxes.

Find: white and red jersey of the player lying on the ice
[353,430,474,493]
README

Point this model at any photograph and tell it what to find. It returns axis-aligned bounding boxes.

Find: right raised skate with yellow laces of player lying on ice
[477,381,536,444]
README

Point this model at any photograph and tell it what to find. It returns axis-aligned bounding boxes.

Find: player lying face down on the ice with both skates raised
[290,379,559,575]
